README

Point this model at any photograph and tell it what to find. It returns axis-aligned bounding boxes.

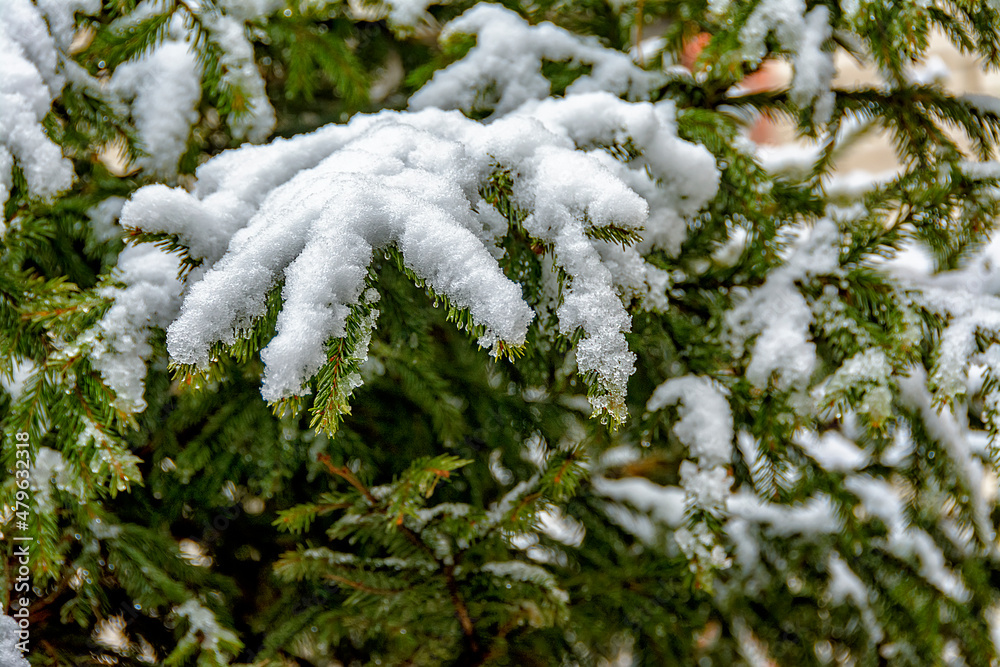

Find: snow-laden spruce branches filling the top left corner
[0,0,284,204]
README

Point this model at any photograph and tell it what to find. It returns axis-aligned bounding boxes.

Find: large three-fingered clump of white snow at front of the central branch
[161,113,532,400]
